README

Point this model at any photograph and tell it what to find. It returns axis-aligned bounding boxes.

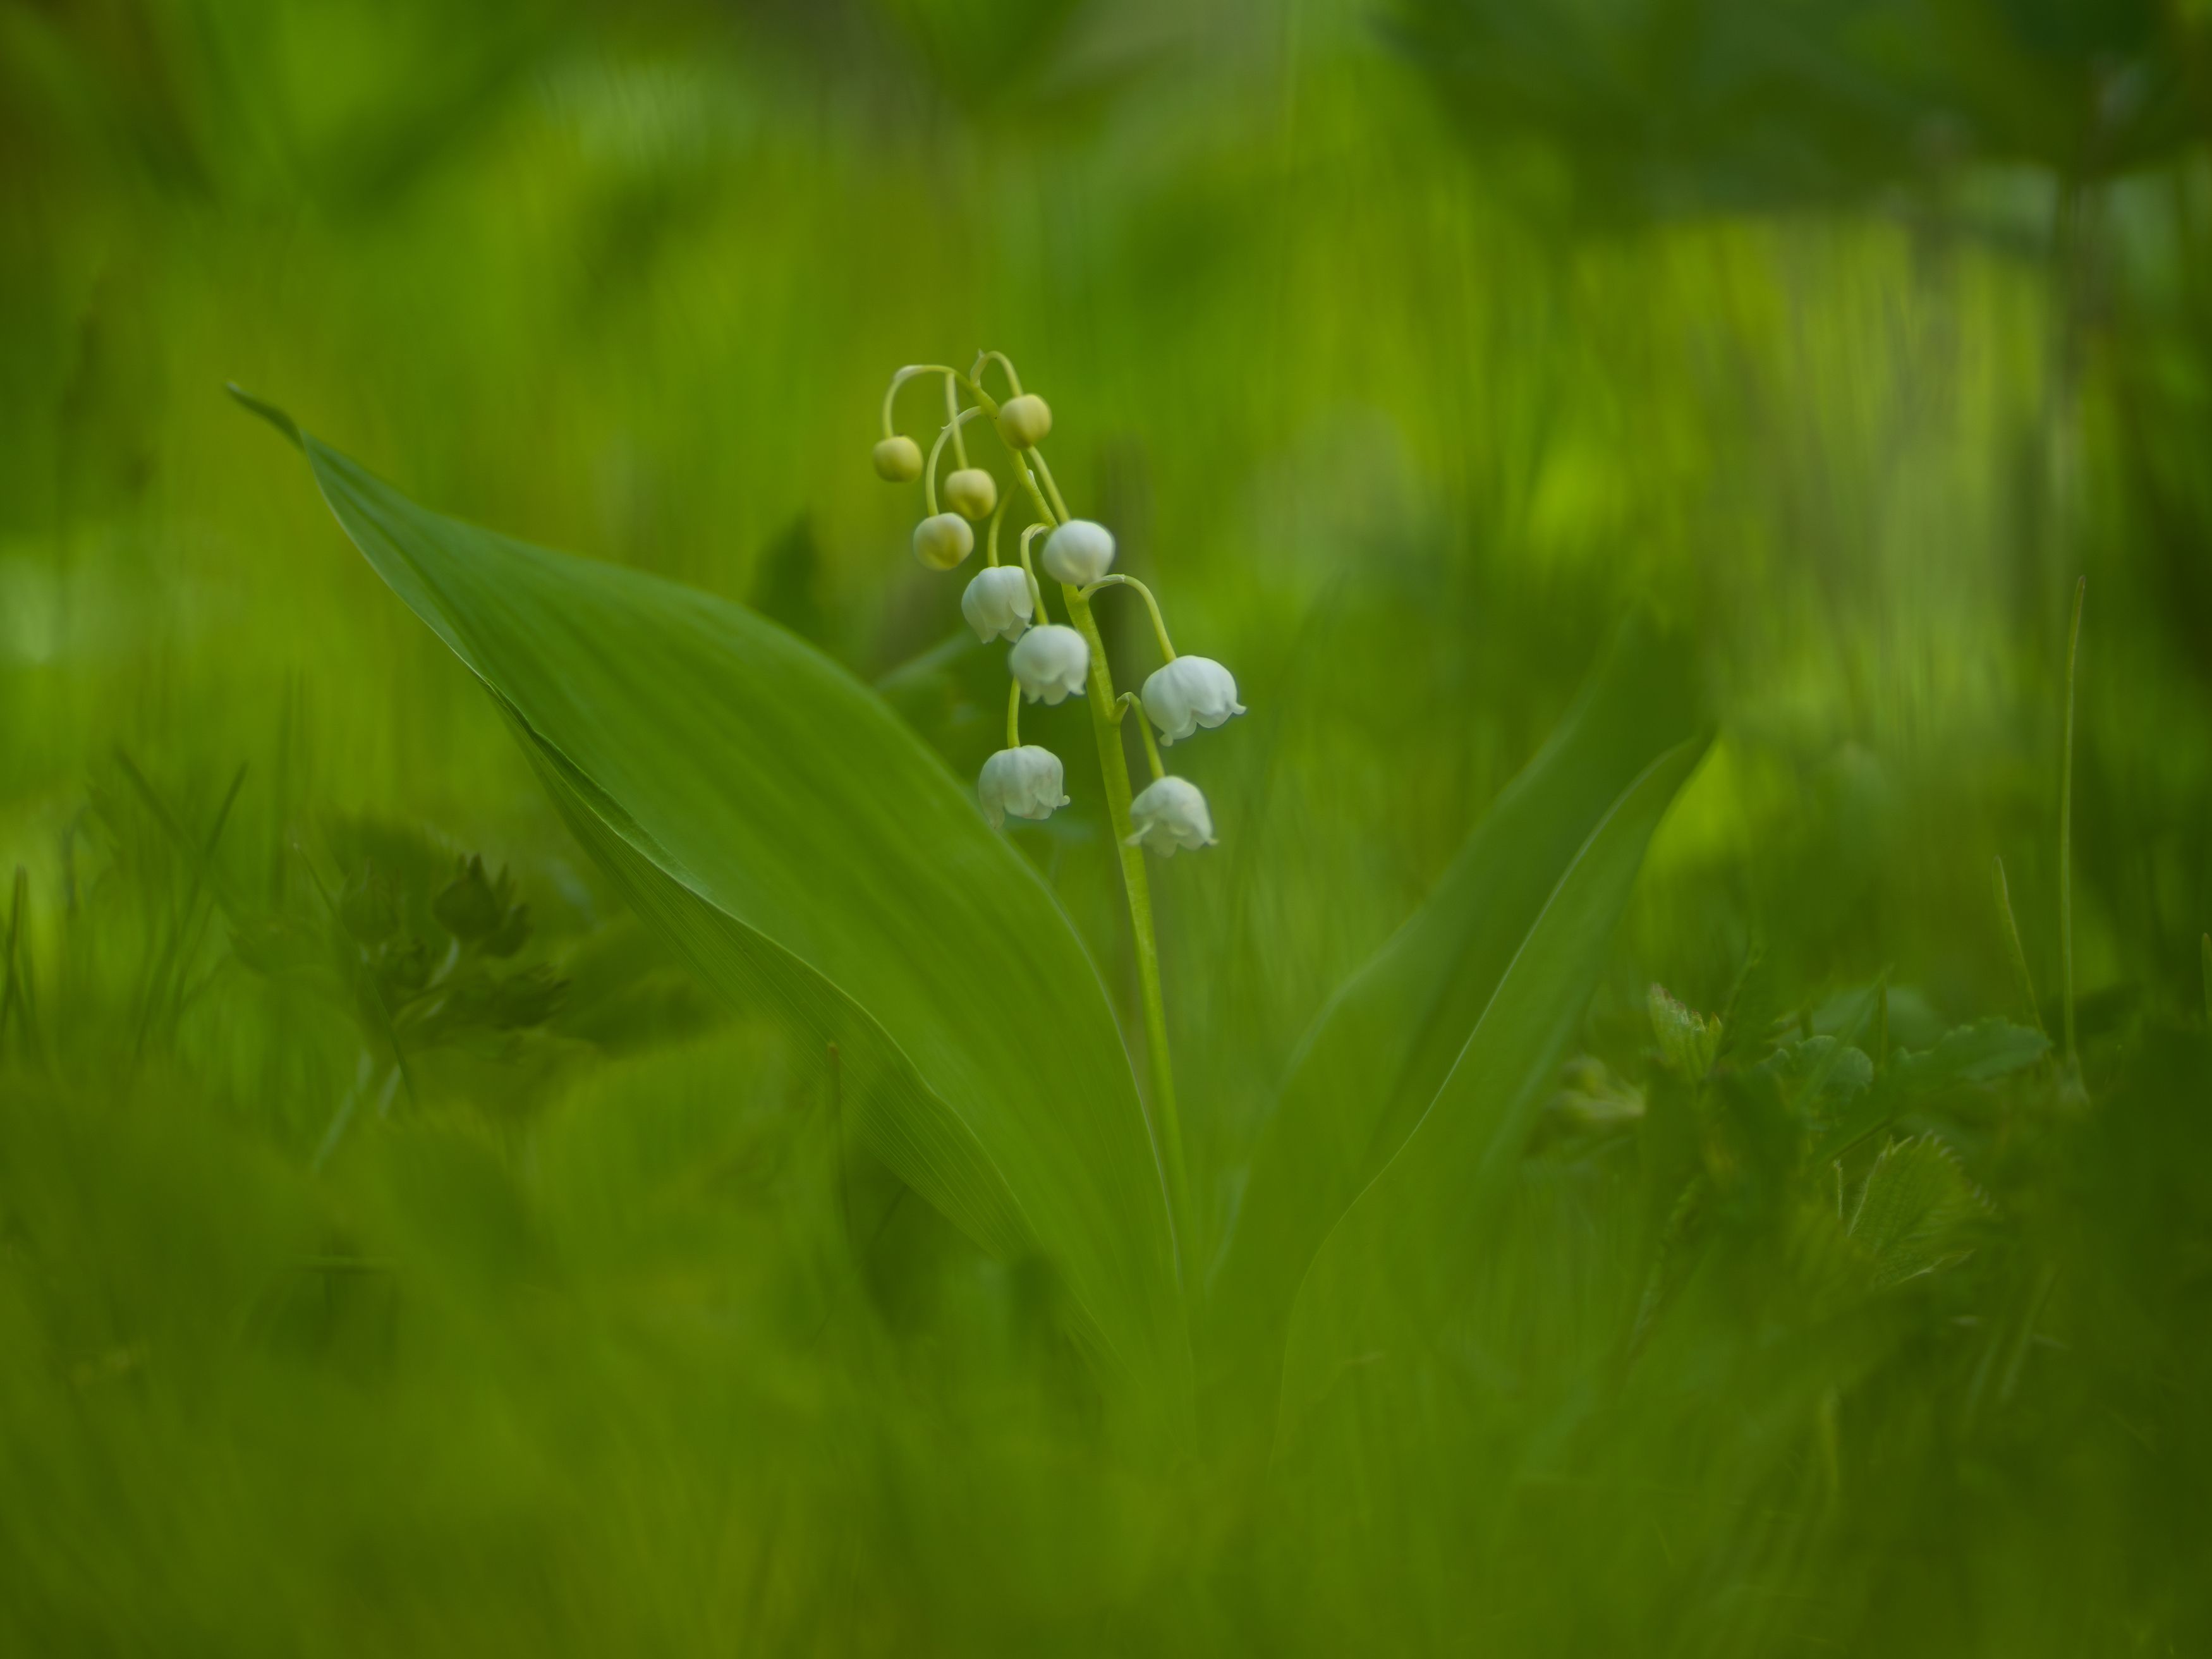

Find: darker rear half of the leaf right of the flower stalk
[1210,617,1697,1427]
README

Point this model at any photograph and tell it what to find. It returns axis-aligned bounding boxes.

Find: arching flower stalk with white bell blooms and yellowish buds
[876,352,1243,1217]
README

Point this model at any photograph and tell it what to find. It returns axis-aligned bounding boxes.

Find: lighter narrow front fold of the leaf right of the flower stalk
[1279,739,1706,1438]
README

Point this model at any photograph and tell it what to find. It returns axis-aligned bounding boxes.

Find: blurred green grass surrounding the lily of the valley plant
[0,0,2212,1653]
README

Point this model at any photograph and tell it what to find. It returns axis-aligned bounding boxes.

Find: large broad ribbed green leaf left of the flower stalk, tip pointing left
[274,418,1188,1402]
